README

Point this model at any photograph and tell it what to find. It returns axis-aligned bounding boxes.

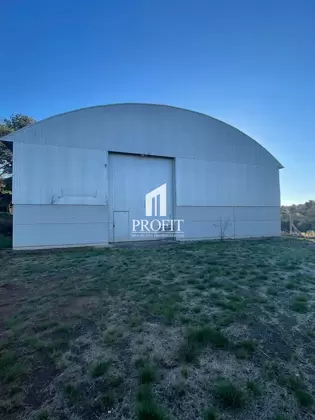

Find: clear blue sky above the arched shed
[0,0,315,204]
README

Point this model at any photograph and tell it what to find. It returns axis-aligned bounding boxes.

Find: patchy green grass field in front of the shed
[0,239,315,420]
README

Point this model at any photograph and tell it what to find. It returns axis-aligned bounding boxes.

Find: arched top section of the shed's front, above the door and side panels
[2,103,283,168]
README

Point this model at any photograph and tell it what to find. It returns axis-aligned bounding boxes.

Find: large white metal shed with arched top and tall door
[4,104,282,249]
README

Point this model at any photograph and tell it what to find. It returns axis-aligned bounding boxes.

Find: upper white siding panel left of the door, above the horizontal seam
[13,143,108,205]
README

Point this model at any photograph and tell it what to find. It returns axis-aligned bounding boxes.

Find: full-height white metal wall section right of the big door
[176,158,280,239]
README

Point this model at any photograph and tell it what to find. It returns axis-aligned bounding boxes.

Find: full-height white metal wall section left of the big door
[13,143,108,248]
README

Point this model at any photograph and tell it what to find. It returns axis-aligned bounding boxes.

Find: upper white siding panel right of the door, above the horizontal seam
[176,159,280,206]
